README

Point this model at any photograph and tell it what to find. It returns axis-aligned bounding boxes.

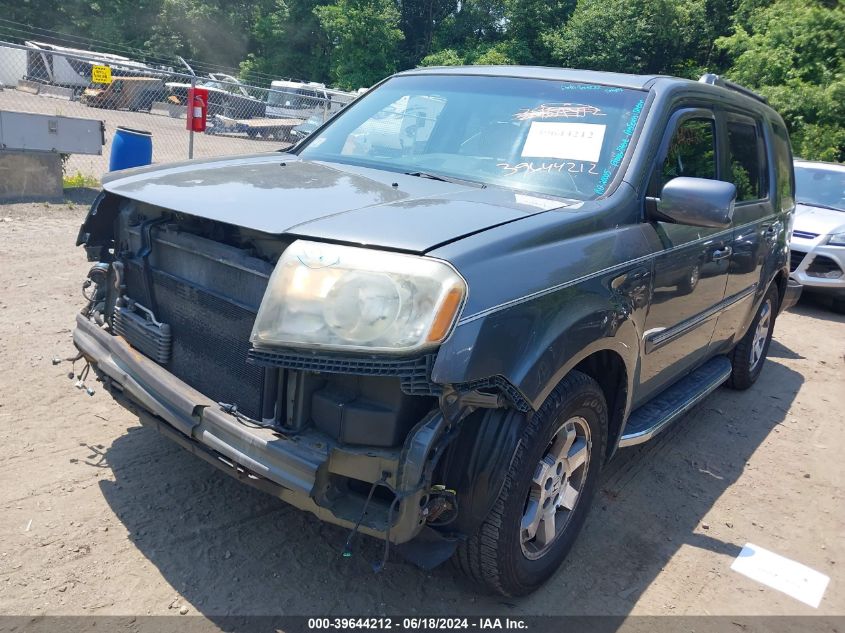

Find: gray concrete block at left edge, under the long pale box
[0,149,64,203]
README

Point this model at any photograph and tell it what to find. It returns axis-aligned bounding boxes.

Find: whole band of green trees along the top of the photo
[0,0,845,160]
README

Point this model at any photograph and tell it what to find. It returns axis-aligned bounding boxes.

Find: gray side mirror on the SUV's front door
[656,176,736,229]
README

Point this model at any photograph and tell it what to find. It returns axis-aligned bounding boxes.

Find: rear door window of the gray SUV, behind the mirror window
[728,120,768,202]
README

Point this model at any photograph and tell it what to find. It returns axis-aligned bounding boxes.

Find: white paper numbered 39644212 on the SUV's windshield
[522,121,607,163]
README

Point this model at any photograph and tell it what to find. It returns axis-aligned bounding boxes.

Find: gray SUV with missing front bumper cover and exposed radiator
[74,67,800,595]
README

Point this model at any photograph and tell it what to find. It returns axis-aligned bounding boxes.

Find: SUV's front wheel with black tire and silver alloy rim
[454,371,607,596]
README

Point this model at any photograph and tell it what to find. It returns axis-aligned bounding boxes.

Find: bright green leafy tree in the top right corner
[716,0,845,161]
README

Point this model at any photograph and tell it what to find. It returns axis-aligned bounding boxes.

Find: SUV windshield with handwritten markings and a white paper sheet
[299,75,646,200]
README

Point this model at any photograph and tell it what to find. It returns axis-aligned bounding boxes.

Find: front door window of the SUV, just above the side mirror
[659,119,716,187]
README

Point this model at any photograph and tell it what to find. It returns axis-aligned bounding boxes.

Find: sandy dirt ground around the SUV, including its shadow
[0,195,845,620]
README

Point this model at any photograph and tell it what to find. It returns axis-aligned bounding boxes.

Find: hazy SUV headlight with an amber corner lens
[250,240,467,353]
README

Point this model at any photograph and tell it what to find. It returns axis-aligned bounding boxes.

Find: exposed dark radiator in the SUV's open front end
[114,226,270,419]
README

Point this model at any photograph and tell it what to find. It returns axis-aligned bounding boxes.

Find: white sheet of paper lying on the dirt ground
[731,543,830,608]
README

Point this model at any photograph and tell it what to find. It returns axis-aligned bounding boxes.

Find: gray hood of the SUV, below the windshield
[103,153,571,252]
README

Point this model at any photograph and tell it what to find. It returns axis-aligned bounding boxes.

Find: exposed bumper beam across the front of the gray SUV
[73,314,438,544]
